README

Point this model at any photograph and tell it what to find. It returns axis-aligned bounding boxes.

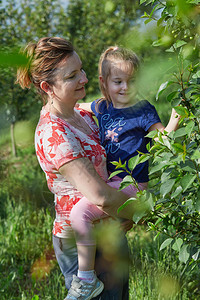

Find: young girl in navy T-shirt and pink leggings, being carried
[67,47,179,299]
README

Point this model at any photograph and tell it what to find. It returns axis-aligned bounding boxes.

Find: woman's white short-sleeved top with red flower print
[35,108,108,237]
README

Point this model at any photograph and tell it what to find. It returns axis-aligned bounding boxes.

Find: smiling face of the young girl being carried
[105,60,133,108]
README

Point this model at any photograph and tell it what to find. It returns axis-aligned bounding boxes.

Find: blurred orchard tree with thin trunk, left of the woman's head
[0,0,64,155]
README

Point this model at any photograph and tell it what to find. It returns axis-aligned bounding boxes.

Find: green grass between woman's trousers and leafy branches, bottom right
[128,225,198,300]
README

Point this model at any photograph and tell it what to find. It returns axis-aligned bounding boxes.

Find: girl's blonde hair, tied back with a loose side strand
[97,46,140,106]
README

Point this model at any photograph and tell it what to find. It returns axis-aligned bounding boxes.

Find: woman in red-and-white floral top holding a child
[17,37,134,300]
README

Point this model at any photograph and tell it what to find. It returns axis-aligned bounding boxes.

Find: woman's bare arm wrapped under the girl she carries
[59,158,134,220]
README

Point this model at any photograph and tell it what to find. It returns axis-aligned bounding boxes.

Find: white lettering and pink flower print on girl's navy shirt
[101,114,126,153]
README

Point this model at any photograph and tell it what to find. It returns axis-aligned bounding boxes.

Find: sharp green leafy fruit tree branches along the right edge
[111,1,200,286]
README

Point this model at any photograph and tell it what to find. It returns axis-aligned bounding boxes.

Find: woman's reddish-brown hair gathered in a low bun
[16,37,74,98]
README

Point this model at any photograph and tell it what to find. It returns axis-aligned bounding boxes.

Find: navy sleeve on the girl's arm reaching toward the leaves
[142,100,161,131]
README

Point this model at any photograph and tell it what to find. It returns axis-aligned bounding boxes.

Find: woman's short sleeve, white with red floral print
[42,123,86,170]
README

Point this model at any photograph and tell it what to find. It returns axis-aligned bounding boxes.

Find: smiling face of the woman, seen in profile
[52,52,88,103]
